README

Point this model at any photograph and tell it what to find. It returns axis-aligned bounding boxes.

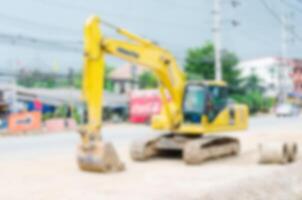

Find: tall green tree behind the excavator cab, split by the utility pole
[185,42,241,93]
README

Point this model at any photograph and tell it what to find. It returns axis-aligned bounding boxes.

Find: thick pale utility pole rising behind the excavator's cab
[213,0,223,81]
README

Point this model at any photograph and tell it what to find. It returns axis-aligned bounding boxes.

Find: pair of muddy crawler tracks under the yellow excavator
[130,134,240,165]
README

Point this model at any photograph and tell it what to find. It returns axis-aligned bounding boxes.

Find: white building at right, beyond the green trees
[238,57,296,97]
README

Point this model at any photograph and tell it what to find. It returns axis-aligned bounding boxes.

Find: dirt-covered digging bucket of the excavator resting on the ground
[78,141,125,172]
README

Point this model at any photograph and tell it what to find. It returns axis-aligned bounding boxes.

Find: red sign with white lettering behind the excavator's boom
[129,90,161,123]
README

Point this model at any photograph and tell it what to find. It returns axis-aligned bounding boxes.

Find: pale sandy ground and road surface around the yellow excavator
[0,116,302,200]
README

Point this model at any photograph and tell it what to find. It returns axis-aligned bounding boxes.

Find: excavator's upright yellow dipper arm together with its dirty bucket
[77,16,124,172]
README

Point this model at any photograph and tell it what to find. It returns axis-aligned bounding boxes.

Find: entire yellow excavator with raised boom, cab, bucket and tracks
[78,16,249,172]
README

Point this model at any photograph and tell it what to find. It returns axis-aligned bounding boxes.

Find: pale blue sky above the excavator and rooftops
[0,0,302,72]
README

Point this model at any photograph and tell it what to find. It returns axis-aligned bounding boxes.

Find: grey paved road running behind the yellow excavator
[0,116,302,158]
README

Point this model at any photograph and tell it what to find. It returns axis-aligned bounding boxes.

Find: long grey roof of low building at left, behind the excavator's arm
[0,84,129,112]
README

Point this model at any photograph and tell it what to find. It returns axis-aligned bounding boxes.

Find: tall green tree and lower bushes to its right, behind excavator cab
[185,42,274,113]
